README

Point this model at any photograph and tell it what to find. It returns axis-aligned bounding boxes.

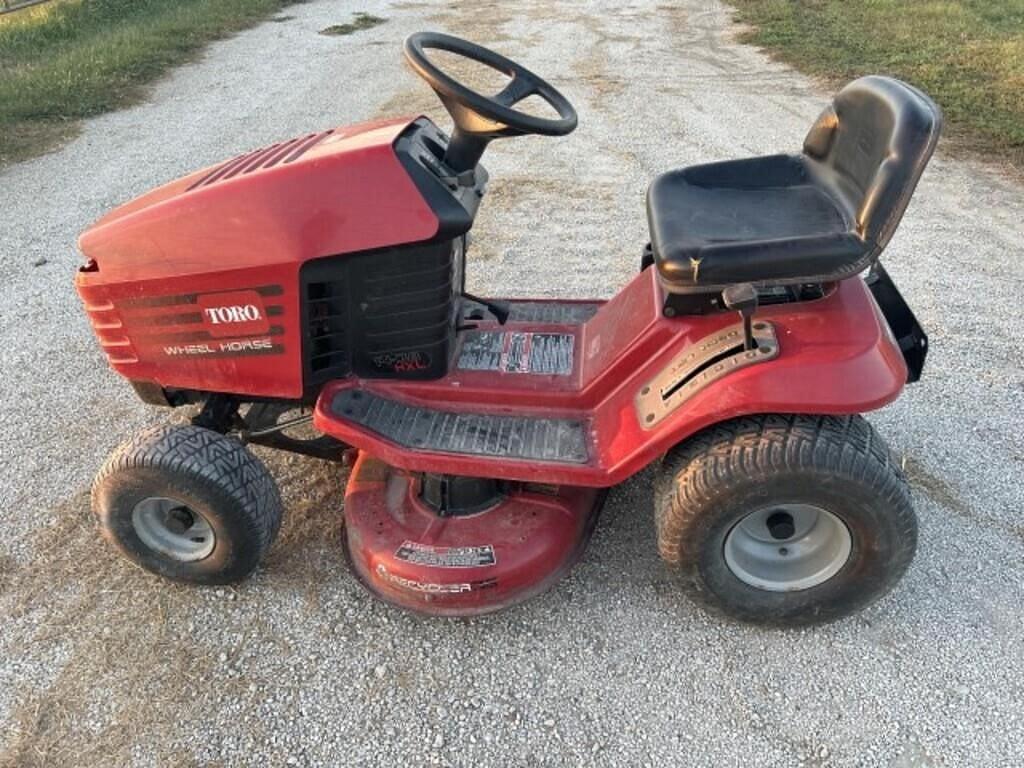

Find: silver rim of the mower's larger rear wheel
[725,504,853,592]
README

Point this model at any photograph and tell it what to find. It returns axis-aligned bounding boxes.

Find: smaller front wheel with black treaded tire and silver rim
[92,425,282,585]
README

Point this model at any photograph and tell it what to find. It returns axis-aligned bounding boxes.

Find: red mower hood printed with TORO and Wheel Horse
[76,120,438,398]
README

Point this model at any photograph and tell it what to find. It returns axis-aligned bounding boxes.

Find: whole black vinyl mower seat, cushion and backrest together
[647,77,942,293]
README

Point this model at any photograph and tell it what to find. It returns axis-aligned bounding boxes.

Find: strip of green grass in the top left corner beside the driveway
[0,0,301,164]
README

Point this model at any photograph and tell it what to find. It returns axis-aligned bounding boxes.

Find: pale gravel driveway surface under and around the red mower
[0,0,1024,768]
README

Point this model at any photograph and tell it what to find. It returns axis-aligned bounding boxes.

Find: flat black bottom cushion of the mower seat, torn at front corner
[647,155,868,290]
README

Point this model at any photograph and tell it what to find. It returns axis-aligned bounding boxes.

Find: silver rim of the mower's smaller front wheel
[131,496,217,562]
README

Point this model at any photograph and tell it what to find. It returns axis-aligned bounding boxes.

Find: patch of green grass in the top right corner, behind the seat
[730,0,1024,170]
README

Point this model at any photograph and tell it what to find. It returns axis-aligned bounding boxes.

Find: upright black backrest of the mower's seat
[804,76,942,257]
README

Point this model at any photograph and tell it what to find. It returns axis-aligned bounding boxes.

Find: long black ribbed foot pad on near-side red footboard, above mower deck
[331,389,588,464]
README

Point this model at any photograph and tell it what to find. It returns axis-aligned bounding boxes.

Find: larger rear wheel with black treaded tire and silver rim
[655,416,918,625]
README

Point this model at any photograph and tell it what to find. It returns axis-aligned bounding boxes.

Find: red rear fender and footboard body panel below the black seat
[314,269,906,486]
